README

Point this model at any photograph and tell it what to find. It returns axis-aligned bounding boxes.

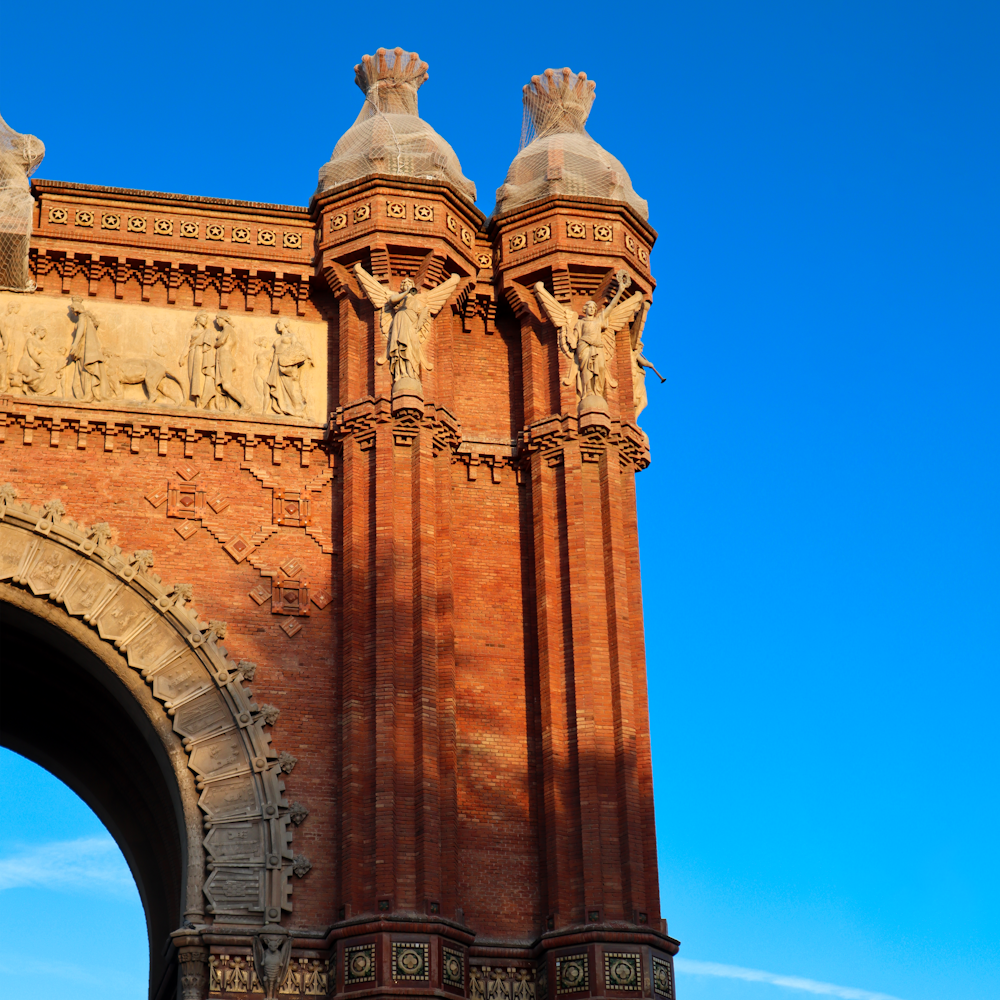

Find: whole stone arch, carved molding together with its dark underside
[0,484,295,995]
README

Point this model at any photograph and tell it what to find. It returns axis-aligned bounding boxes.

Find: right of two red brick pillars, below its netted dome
[491,198,676,996]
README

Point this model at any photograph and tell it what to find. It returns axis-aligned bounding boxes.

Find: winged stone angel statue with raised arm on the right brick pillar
[535,271,643,408]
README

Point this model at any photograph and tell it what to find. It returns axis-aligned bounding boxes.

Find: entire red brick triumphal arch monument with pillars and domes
[0,50,678,1000]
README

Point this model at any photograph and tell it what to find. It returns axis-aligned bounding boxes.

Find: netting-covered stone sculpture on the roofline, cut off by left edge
[0,117,45,292]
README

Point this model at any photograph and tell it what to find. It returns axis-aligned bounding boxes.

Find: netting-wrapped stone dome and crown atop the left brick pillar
[316,48,476,201]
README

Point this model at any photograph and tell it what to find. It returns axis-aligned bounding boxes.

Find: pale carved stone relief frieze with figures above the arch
[0,293,327,420]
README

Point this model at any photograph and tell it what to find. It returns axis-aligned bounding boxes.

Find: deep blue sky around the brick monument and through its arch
[0,0,1000,1000]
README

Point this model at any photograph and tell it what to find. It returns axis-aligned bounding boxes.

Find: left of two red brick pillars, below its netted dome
[314,179,482,994]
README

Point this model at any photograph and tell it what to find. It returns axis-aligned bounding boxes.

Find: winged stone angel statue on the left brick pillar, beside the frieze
[354,264,459,389]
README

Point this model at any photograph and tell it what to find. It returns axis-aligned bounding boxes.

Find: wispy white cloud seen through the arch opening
[0,837,136,896]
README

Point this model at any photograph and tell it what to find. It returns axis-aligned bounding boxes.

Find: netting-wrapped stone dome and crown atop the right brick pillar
[494,68,649,219]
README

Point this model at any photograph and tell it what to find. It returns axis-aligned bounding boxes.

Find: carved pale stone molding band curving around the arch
[0,483,308,926]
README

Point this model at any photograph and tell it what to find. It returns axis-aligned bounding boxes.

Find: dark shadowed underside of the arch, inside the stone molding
[0,584,191,1000]
